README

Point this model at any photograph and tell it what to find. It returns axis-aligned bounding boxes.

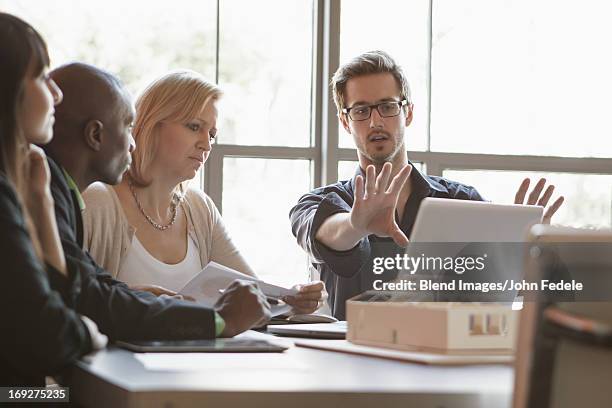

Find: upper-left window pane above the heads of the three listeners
[0,0,216,94]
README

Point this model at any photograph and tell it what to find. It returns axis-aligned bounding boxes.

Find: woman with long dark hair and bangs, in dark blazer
[0,13,106,386]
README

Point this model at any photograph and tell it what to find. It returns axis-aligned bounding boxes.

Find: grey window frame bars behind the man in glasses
[200,0,612,225]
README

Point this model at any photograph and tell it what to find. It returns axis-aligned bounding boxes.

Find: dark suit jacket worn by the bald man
[48,157,215,340]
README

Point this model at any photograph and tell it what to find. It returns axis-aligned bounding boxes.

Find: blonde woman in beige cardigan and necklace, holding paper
[83,70,326,313]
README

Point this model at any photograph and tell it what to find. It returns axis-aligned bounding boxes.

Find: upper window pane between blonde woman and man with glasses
[219,0,312,146]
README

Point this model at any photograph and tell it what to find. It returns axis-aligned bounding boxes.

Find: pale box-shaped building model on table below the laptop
[347,292,519,354]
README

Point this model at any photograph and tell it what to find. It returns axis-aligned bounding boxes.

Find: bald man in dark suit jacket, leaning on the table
[45,63,270,340]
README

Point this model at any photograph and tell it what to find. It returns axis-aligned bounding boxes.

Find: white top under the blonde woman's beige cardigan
[117,234,202,292]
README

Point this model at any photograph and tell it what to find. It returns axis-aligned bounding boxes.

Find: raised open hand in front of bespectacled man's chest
[350,163,412,247]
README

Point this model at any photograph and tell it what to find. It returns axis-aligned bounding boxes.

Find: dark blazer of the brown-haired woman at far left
[0,174,92,387]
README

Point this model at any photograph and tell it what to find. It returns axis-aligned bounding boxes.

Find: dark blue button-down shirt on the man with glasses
[289,162,483,320]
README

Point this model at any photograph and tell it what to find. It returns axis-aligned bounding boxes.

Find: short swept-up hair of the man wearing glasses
[331,51,412,114]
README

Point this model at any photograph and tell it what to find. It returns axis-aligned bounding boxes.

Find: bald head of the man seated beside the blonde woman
[46,63,135,187]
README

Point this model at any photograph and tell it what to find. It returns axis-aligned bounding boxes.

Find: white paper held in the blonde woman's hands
[179,262,297,316]
